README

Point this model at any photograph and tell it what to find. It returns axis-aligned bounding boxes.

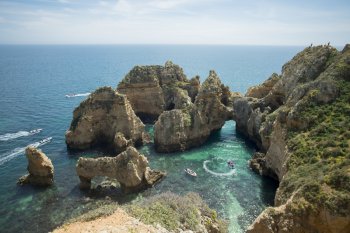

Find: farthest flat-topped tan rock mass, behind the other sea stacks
[117,61,200,122]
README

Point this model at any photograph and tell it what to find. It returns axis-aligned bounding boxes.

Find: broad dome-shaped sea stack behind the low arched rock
[66,87,145,153]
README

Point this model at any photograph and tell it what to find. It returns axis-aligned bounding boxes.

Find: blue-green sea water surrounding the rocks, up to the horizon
[0,46,301,232]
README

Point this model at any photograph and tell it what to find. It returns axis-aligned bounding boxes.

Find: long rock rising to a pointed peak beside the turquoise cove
[154,71,233,152]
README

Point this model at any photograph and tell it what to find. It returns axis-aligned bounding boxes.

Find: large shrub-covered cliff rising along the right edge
[234,45,350,233]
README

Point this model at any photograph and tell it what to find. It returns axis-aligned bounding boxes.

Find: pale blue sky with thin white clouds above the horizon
[0,0,350,46]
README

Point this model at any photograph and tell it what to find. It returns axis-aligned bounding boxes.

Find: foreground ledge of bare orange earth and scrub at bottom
[53,192,227,233]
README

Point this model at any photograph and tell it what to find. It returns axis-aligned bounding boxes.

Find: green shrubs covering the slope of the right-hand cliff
[279,70,350,216]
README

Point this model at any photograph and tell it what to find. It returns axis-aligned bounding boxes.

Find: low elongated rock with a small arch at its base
[77,146,165,192]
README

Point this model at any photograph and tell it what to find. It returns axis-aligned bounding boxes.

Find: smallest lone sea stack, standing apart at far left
[18,147,54,186]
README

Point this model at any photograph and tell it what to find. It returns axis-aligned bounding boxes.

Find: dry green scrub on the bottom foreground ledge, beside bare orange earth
[126,192,227,232]
